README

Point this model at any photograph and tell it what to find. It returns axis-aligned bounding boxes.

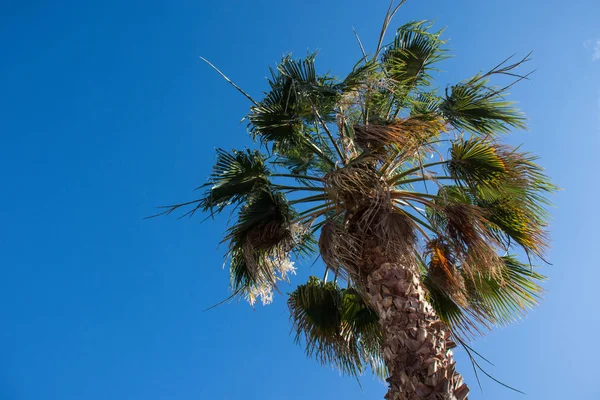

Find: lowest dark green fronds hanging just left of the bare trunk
[288,277,384,376]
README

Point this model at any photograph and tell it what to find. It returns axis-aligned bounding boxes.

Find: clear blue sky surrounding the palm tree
[0,0,600,400]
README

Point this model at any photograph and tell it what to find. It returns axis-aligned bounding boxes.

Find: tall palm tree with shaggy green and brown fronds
[157,10,554,400]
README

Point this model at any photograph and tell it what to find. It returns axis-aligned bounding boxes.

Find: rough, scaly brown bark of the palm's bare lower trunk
[367,263,469,400]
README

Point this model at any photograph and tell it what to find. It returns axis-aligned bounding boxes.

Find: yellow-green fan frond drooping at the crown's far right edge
[447,139,556,255]
